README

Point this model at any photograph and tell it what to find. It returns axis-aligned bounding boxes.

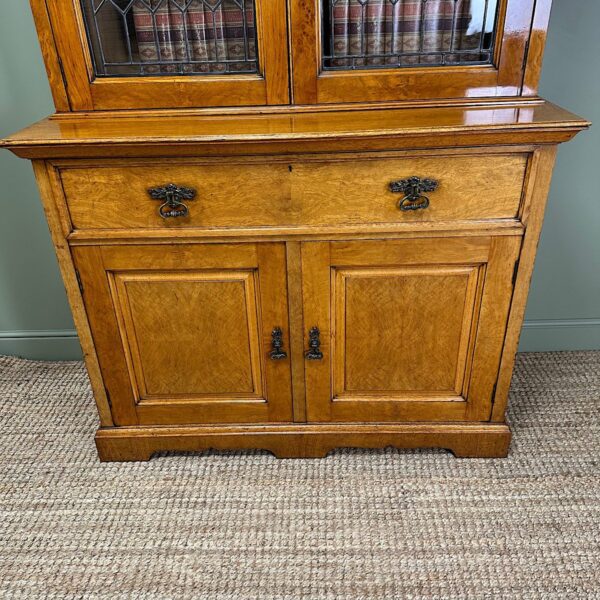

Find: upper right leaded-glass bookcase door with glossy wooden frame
[291,0,535,104]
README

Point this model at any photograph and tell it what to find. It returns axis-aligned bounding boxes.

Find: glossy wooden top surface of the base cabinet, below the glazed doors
[0,101,590,157]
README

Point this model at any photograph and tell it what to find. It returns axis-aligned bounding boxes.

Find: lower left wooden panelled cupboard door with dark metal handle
[73,243,292,425]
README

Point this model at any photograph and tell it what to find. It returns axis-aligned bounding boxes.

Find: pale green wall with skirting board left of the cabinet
[0,0,80,358]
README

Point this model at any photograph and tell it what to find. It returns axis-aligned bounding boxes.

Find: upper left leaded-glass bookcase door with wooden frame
[47,0,289,111]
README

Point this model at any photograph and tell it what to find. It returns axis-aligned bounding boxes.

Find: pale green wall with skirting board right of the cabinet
[521,0,600,350]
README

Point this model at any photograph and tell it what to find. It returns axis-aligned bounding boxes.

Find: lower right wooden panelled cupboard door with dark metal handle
[302,236,520,422]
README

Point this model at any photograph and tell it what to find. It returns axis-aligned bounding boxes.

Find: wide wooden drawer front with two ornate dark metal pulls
[61,154,527,229]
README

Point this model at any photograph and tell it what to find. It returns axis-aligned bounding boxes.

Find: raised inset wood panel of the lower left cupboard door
[111,270,262,401]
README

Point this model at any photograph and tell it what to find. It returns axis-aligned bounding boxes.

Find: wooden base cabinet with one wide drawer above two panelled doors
[4,119,587,461]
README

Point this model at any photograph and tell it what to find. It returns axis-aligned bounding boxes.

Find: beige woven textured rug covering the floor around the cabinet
[0,352,600,600]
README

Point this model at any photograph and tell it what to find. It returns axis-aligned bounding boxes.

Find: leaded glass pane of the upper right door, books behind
[322,0,498,70]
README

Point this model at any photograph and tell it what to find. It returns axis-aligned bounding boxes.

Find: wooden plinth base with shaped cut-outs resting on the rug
[96,422,511,462]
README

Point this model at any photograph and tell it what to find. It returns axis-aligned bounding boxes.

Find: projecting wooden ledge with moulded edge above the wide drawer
[0,101,590,159]
